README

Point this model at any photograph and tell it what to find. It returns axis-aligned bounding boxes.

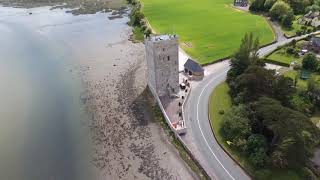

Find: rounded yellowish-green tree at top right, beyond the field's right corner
[269,1,291,21]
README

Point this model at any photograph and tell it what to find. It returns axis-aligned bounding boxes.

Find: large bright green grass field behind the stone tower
[141,0,275,63]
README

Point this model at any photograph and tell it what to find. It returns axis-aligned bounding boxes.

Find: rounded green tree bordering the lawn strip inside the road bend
[222,105,251,141]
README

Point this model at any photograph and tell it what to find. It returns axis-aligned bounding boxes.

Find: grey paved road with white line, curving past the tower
[184,31,320,180]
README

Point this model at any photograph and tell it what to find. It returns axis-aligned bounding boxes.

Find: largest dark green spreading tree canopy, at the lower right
[251,97,320,168]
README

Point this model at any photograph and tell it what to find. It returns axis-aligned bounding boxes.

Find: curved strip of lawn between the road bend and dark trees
[209,82,301,180]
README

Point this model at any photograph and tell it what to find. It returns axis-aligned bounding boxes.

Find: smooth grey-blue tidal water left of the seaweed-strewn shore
[0,7,126,180]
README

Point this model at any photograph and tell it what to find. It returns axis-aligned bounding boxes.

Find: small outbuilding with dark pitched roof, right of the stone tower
[184,59,204,80]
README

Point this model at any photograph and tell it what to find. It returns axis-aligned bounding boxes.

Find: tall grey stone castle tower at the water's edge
[145,35,179,96]
